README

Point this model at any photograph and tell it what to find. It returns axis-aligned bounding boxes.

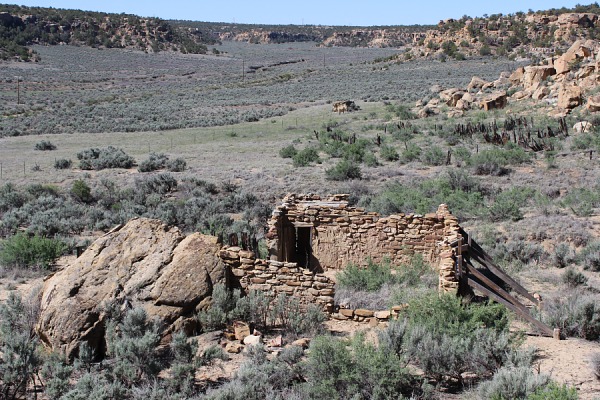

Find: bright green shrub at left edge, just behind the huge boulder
[0,233,67,268]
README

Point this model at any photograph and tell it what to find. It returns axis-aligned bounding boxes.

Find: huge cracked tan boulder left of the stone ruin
[37,218,226,358]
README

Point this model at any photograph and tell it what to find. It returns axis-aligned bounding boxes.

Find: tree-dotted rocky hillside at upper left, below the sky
[0,4,214,61]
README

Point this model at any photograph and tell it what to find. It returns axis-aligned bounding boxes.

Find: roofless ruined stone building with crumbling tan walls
[220,194,459,312]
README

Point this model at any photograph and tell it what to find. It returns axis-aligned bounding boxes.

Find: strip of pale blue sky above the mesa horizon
[5,0,592,26]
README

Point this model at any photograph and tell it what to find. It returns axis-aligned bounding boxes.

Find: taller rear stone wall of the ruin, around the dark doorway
[267,195,458,271]
